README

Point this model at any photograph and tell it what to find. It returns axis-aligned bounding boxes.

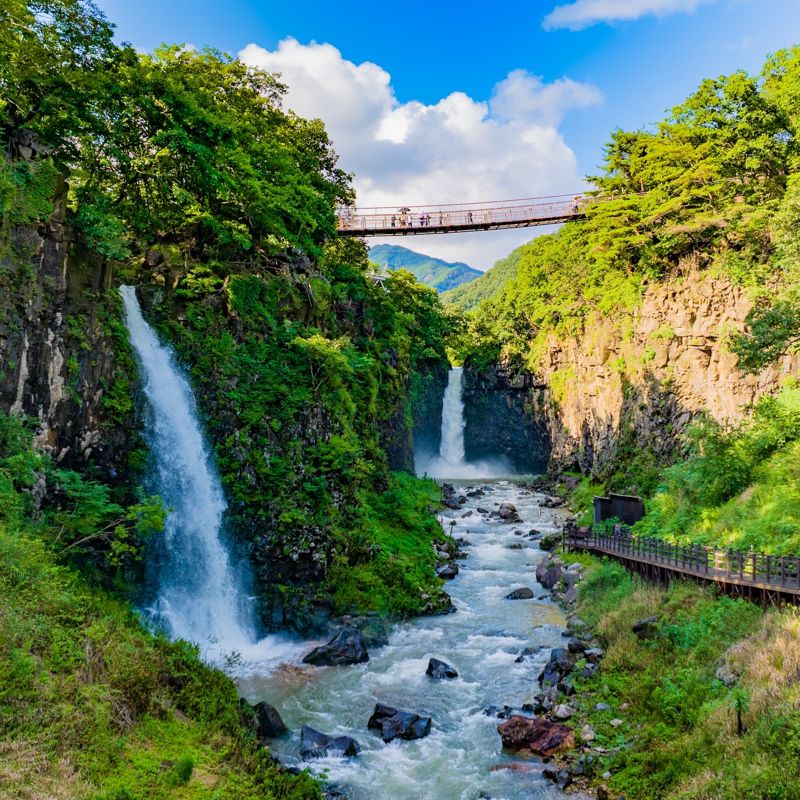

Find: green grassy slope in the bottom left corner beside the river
[0,483,320,800]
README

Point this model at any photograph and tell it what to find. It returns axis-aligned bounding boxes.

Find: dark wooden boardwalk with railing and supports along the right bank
[564,530,800,606]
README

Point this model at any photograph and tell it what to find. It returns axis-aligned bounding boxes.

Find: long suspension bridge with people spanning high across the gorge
[338,193,596,237]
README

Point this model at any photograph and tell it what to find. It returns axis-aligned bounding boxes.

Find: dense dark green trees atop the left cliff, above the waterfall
[0,0,352,262]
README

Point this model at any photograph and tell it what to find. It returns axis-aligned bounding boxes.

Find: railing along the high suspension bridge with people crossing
[338,195,588,232]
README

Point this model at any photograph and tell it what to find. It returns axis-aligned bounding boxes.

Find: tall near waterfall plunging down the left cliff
[120,286,296,666]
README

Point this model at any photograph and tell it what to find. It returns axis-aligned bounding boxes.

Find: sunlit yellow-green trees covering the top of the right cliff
[454,49,800,370]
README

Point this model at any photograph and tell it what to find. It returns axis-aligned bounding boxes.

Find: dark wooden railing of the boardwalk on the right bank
[565,529,800,590]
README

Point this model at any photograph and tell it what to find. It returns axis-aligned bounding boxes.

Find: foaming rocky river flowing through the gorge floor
[240,480,565,800]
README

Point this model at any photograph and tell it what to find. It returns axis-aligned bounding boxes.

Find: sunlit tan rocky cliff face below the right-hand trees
[538,263,800,471]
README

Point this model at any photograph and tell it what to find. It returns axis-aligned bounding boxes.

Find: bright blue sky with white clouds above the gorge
[98,0,800,268]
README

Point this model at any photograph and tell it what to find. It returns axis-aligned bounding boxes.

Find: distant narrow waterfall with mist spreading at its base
[417,367,514,480]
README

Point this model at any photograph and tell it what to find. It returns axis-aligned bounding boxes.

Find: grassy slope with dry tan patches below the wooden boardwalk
[560,556,800,800]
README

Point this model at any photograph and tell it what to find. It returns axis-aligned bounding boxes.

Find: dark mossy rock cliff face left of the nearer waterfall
[0,216,137,481]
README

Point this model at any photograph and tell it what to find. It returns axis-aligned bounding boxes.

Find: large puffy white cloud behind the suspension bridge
[239,38,602,268]
